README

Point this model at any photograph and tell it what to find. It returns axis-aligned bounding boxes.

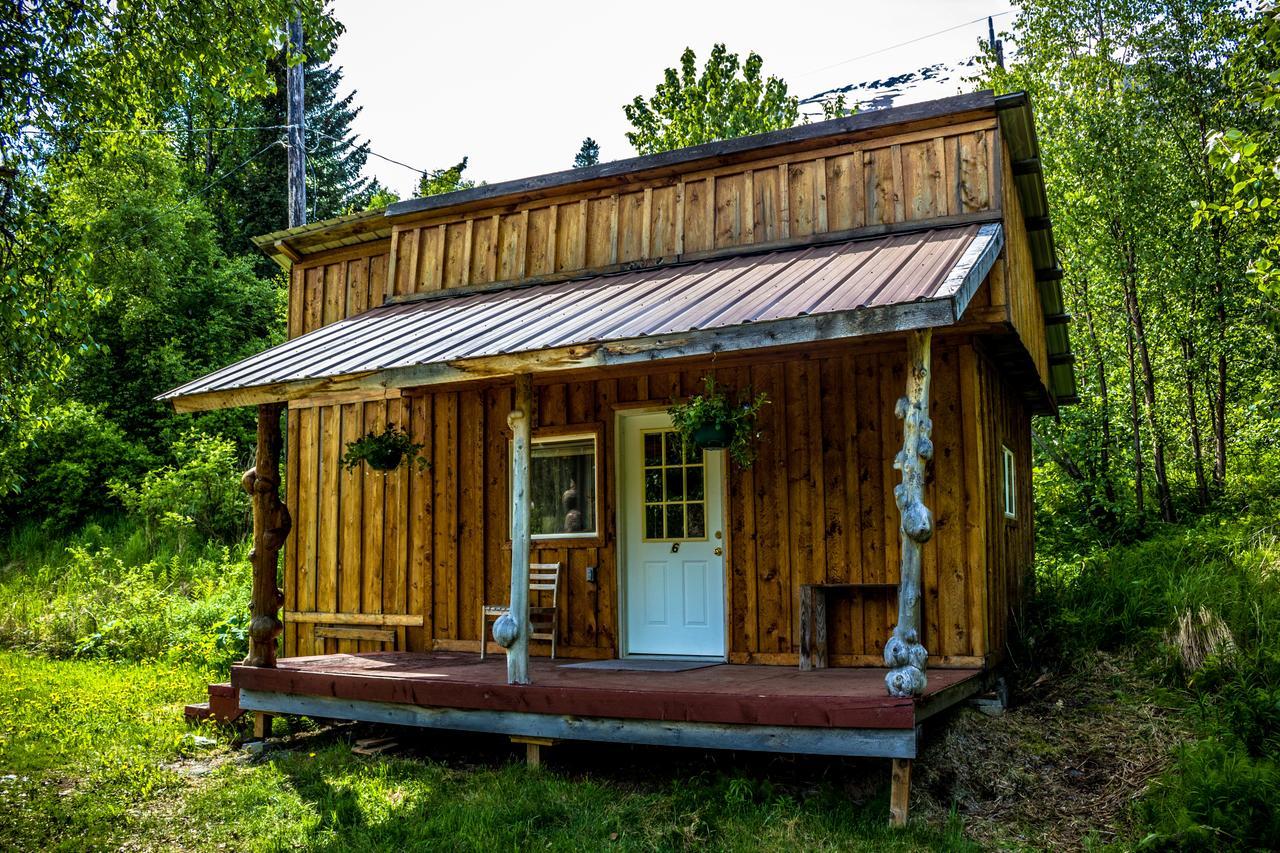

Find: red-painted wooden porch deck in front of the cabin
[232,652,983,730]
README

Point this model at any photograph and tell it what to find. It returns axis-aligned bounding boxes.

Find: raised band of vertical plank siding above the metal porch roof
[383,119,1010,296]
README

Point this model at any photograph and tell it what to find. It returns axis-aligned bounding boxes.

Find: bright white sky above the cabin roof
[334,0,1012,197]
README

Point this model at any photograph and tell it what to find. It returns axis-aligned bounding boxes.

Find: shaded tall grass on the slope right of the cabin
[1023,502,1280,849]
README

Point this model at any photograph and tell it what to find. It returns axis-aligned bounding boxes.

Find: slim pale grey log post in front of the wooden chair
[493,373,534,684]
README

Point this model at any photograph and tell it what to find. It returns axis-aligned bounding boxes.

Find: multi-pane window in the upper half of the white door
[644,430,707,539]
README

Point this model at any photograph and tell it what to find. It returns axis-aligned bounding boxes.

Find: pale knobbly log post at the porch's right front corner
[884,329,933,697]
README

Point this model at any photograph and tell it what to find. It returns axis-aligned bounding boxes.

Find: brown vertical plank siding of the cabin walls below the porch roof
[285,338,1030,665]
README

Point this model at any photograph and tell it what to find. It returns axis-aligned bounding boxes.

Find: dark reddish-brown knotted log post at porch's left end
[241,403,293,666]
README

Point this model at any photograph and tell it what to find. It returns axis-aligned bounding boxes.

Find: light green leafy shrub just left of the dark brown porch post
[111,429,250,544]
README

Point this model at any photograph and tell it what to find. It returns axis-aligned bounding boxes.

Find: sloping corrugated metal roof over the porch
[160,223,1004,409]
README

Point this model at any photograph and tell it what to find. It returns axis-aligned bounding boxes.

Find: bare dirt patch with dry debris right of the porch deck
[911,653,1188,849]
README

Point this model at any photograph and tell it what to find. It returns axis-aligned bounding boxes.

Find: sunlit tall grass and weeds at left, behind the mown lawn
[0,517,251,671]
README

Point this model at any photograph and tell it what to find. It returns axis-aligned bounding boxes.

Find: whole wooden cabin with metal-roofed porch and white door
[161,92,1075,820]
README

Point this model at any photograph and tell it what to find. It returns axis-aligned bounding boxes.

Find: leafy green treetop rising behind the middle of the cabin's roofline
[622,44,800,154]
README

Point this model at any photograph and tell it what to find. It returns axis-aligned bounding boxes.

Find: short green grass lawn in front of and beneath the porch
[0,652,972,850]
